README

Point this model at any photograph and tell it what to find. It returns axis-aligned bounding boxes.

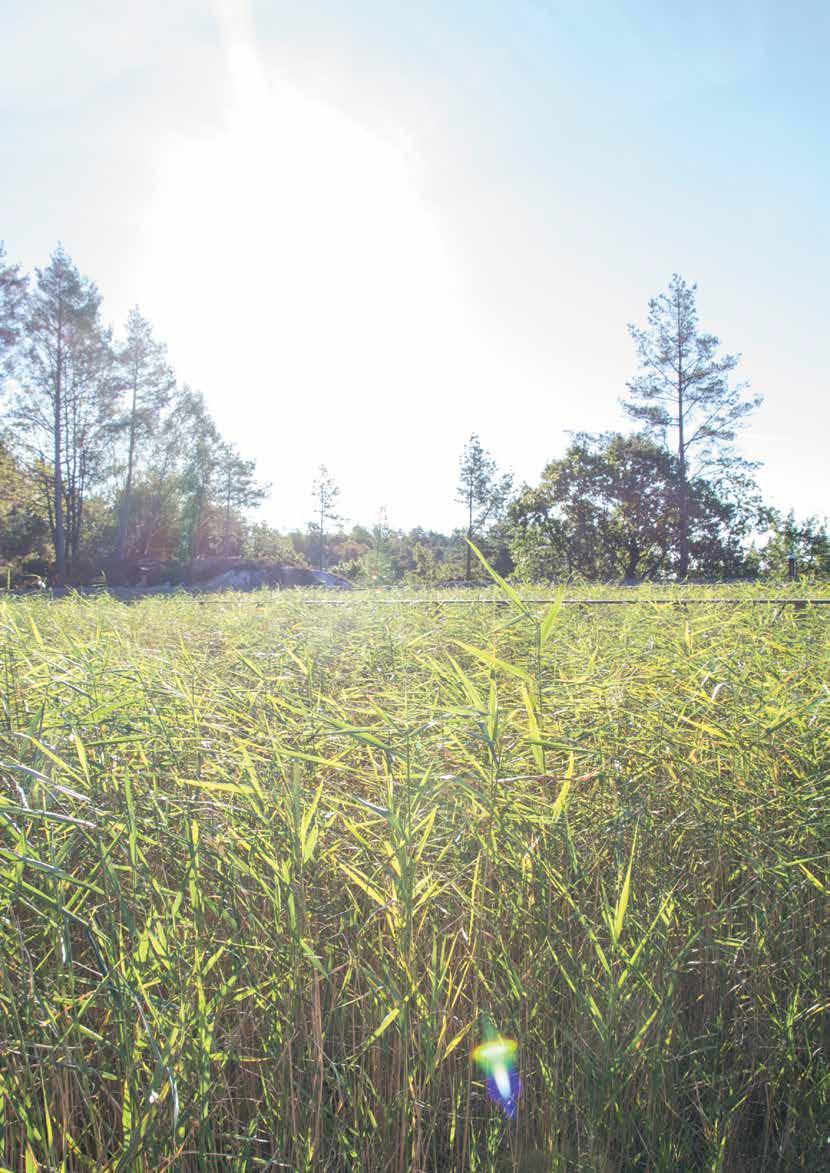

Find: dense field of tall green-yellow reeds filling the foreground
[0,584,830,1173]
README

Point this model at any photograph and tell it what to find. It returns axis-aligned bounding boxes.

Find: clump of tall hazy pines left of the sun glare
[0,245,275,581]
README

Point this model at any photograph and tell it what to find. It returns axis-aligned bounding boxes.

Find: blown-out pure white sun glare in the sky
[135,0,463,523]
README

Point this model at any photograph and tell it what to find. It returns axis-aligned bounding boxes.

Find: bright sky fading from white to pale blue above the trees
[0,0,830,529]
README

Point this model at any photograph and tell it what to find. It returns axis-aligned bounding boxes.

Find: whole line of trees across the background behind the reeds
[0,244,830,583]
